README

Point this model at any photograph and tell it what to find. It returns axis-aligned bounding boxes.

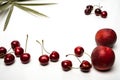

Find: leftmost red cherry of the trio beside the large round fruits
[61,60,72,71]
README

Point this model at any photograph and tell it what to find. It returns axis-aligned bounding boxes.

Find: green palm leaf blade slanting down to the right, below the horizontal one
[15,3,48,17]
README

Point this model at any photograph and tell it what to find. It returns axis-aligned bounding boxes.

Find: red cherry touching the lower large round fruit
[80,60,92,72]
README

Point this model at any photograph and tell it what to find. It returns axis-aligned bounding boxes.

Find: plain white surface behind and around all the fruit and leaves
[0,0,120,80]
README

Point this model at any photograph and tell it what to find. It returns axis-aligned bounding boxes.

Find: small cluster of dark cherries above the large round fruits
[84,5,108,18]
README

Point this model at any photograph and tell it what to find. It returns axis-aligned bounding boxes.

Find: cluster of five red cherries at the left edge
[0,35,31,65]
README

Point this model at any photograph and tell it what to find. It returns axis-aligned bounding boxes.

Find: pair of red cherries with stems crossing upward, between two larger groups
[36,40,60,66]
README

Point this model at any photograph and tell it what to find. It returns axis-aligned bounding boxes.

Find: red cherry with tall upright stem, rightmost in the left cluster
[20,35,31,64]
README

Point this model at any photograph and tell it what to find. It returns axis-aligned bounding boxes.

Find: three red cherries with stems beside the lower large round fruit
[61,46,92,72]
